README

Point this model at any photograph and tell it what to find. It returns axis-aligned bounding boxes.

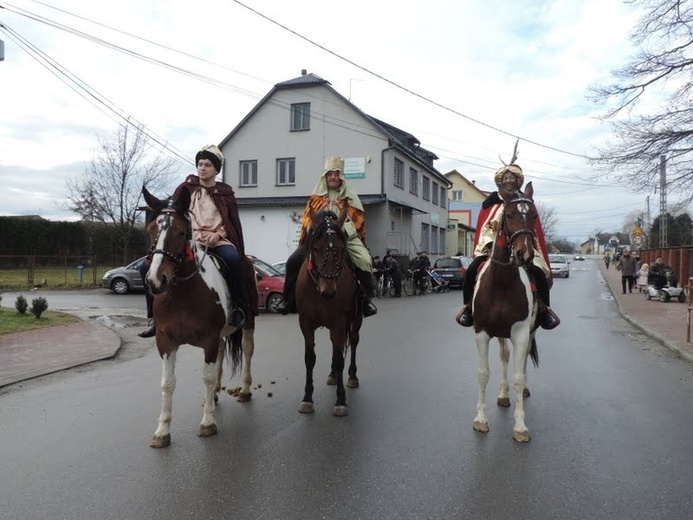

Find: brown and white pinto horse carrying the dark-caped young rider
[142,188,257,448]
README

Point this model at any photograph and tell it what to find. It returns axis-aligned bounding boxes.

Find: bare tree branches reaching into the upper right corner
[591,0,693,202]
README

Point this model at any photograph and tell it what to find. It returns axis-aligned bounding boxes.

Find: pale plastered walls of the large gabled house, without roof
[222,86,448,263]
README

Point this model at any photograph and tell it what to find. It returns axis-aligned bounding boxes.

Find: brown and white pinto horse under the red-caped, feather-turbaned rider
[472,182,539,442]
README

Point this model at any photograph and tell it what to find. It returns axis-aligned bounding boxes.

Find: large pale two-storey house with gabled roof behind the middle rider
[219,70,451,262]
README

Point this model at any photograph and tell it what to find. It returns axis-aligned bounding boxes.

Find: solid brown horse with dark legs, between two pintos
[296,208,363,416]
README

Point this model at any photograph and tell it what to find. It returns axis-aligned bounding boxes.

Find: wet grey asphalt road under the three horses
[0,261,693,520]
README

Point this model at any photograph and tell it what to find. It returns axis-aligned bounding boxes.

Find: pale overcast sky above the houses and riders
[0,0,674,243]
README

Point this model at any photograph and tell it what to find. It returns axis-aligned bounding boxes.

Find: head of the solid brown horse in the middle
[307,207,348,300]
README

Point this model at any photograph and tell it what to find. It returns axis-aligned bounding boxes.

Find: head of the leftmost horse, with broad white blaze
[142,187,192,294]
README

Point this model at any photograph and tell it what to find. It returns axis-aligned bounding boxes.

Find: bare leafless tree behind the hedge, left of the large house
[61,122,176,262]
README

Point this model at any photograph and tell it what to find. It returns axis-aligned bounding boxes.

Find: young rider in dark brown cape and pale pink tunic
[174,145,259,327]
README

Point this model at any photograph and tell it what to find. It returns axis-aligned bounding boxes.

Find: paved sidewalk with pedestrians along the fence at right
[597,261,693,361]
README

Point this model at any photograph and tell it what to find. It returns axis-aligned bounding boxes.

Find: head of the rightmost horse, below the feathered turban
[503,182,538,266]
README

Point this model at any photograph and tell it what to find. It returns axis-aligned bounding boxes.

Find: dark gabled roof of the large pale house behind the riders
[219,70,450,187]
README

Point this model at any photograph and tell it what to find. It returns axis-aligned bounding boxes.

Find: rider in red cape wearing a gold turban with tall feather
[456,143,561,329]
